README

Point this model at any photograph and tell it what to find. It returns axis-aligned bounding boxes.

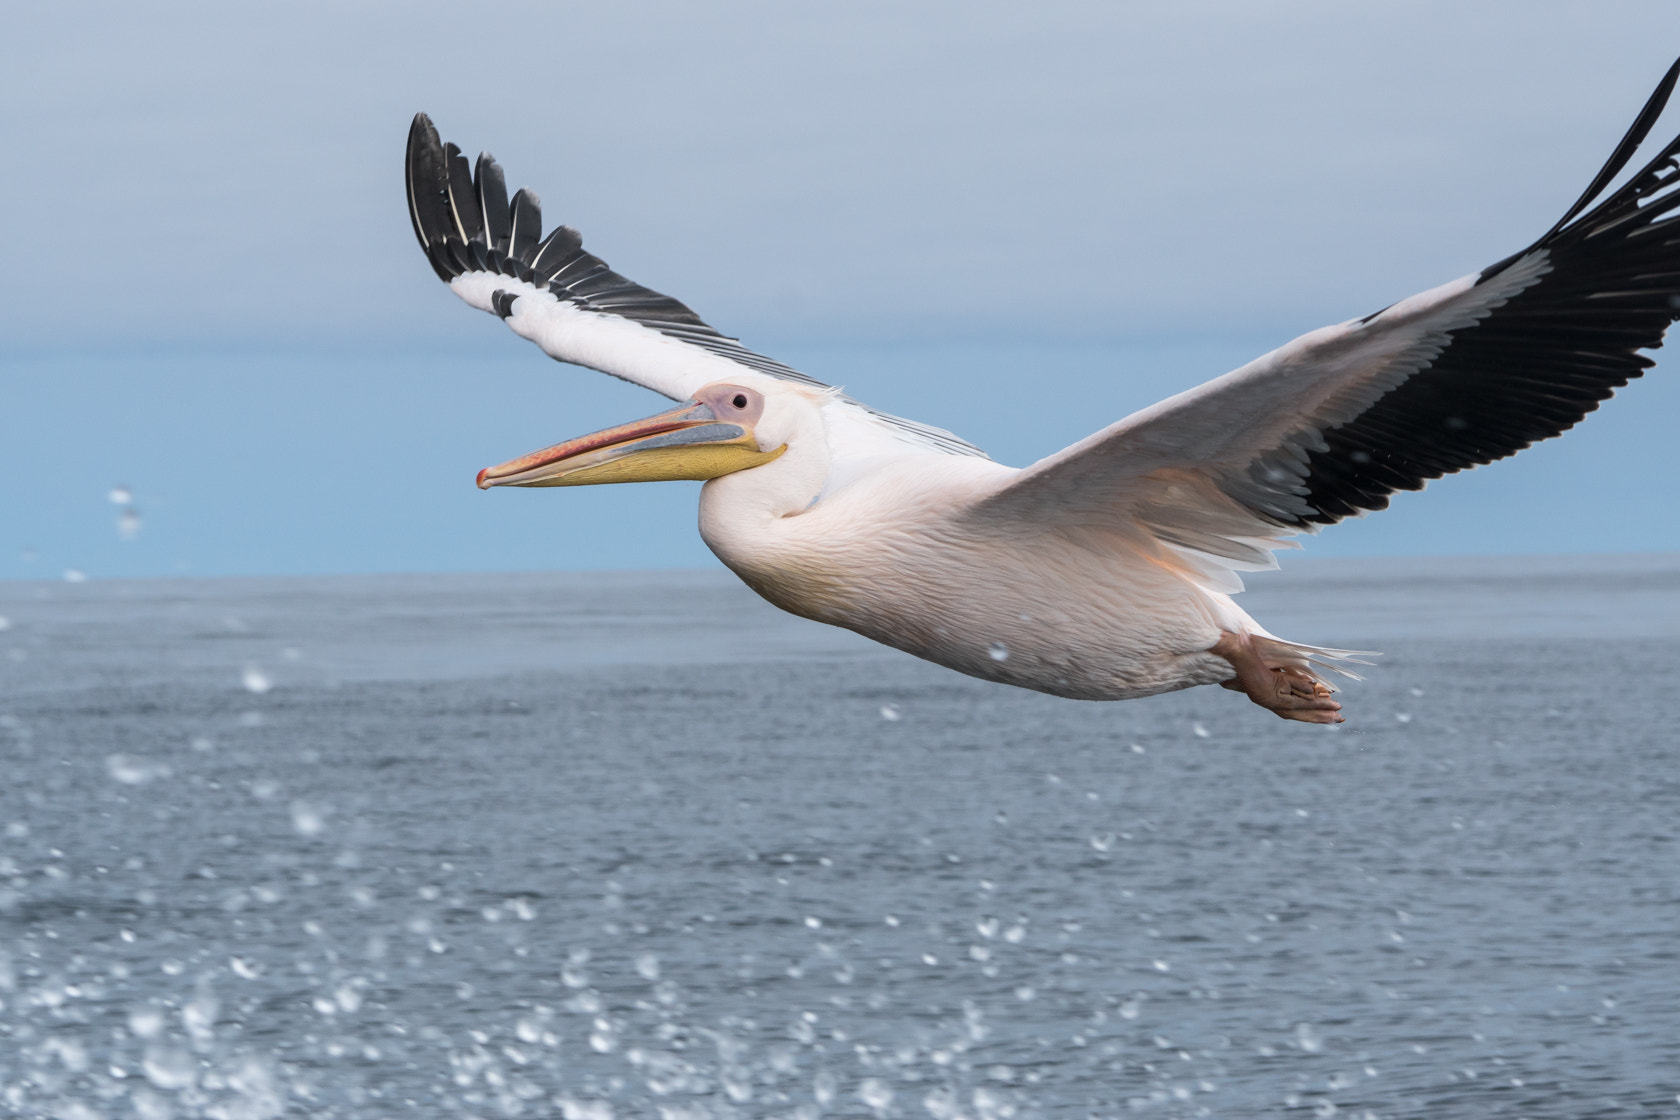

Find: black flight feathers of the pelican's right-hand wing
[1295,60,1680,527]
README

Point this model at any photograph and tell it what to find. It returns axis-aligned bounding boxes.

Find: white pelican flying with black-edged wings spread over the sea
[407,62,1680,724]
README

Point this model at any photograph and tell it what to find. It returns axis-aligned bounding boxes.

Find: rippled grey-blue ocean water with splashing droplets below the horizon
[0,556,1680,1120]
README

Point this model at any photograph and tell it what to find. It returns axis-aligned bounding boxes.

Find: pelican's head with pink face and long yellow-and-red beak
[479,381,791,490]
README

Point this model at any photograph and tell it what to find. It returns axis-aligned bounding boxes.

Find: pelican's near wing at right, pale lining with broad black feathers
[969,62,1680,569]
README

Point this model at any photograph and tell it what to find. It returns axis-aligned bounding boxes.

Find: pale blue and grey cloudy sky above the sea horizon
[0,0,1680,578]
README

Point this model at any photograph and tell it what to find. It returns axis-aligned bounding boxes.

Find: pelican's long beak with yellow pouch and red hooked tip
[479,401,788,490]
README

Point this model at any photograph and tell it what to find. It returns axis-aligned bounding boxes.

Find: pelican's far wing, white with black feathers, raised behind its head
[405,113,984,457]
